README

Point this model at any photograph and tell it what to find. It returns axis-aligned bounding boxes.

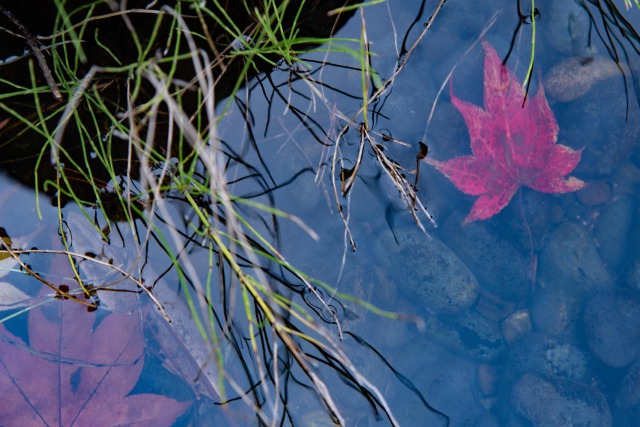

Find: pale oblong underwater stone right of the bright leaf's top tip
[544,56,622,102]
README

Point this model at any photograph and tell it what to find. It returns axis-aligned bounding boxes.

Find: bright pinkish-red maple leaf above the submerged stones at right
[426,40,585,224]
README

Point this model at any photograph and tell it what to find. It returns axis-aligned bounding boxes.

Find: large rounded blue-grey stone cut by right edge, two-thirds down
[584,290,640,367]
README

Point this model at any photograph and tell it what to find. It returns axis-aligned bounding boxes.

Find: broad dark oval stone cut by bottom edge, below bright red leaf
[511,373,612,427]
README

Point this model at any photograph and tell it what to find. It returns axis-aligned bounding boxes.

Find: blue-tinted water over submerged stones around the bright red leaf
[1,0,640,426]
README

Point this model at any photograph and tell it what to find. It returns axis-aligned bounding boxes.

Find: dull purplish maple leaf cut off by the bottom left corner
[0,301,188,426]
